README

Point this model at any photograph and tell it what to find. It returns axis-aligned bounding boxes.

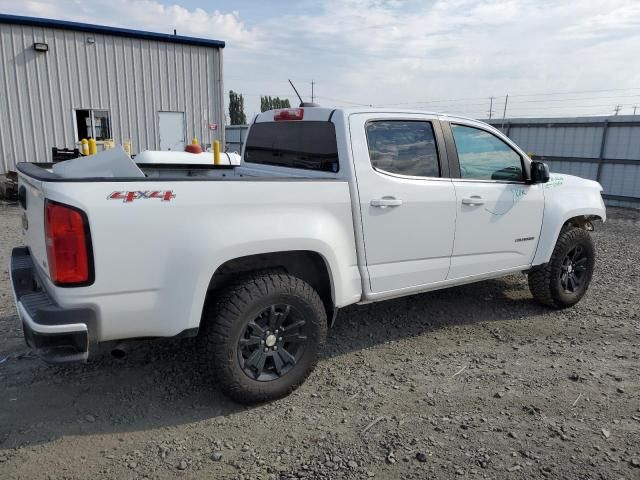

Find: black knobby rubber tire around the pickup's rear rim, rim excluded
[197,272,327,404]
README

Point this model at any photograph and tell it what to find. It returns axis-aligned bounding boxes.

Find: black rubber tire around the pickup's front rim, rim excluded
[528,226,596,309]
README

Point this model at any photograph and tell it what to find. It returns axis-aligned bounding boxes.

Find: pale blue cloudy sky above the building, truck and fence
[0,0,640,118]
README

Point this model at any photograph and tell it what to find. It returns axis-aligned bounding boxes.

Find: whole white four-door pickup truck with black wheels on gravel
[11,107,606,402]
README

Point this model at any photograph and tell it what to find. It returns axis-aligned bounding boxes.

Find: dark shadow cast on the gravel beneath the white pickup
[0,277,544,450]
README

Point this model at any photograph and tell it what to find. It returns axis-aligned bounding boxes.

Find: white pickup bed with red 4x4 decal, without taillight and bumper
[18,163,361,341]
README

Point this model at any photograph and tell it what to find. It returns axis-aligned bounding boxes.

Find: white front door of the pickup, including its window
[445,124,544,279]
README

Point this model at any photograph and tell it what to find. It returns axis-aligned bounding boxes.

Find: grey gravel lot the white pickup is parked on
[0,206,640,479]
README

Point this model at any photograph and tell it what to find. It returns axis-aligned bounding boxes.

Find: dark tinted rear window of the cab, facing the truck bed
[244,120,340,173]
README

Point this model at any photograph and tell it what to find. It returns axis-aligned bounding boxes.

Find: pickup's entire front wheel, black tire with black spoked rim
[529,227,596,309]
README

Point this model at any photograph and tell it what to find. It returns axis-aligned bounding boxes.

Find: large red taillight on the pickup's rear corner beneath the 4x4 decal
[44,200,93,285]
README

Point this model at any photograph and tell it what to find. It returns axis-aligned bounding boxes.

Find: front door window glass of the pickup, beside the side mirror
[451,124,524,182]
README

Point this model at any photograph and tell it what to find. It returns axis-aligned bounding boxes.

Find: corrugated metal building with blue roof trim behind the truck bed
[0,15,224,173]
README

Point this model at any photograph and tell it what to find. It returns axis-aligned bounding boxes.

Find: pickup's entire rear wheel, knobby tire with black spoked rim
[198,273,327,403]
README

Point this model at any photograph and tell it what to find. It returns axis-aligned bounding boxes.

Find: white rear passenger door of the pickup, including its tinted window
[349,113,456,293]
